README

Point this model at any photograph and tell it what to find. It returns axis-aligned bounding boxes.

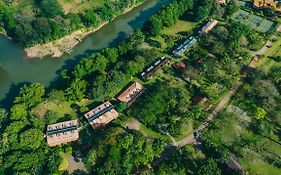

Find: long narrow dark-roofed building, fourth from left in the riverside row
[141,57,170,80]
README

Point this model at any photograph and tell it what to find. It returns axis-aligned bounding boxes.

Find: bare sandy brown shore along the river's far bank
[24,1,146,59]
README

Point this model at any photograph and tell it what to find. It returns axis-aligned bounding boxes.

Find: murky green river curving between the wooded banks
[0,0,172,106]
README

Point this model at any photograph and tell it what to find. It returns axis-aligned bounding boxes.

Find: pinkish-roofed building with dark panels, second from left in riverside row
[84,101,118,129]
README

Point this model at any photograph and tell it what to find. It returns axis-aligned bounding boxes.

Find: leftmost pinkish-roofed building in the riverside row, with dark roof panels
[46,120,79,147]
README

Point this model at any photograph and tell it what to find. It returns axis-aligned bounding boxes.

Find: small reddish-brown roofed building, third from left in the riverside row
[117,82,145,104]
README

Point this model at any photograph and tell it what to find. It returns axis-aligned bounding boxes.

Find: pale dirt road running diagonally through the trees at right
[172,41,272,147]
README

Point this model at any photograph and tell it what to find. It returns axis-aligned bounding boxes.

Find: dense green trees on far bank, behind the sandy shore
[0,0,144,47]
